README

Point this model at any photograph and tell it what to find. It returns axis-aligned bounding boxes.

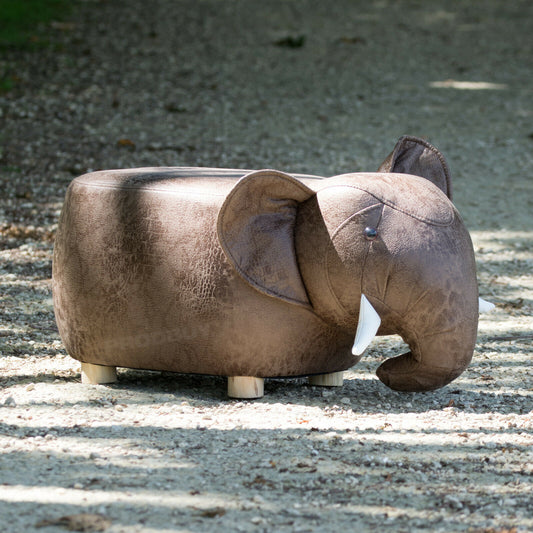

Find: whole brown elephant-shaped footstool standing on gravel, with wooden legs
[53,136,490,398]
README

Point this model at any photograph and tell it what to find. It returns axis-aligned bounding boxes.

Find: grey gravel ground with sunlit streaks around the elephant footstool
[0,0,533,533]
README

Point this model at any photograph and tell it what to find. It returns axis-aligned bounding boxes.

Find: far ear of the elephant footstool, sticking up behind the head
[378,135,452,200]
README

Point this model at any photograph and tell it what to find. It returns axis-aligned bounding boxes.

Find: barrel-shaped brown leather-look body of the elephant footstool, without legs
[54,168,354,377]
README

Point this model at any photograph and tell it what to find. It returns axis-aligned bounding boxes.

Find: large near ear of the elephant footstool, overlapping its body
[217,170,315,307]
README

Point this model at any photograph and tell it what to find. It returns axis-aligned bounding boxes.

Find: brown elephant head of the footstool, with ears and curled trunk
[218,137,479,391]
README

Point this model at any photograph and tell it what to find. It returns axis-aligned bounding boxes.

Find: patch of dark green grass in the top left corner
[0,0,69,49]
